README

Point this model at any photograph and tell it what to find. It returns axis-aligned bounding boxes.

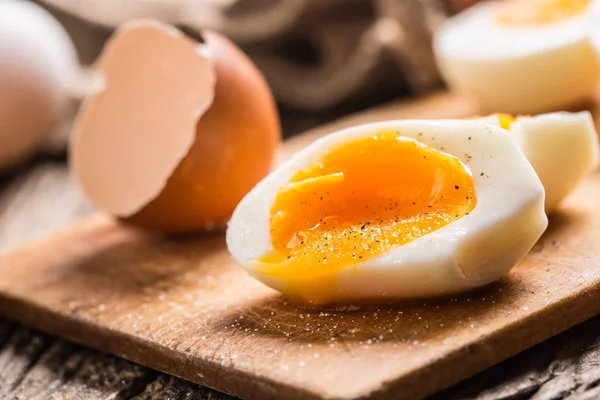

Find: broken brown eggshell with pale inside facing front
[70,20,280,233]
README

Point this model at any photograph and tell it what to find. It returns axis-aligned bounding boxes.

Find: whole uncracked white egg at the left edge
[0,0,78,171]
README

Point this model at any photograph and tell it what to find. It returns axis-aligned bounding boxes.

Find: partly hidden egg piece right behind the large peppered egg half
[480,111,600,213]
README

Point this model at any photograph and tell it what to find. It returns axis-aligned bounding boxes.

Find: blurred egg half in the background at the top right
[434,0,599,114]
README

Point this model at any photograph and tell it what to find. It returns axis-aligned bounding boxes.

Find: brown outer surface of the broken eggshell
[130,32,280,232]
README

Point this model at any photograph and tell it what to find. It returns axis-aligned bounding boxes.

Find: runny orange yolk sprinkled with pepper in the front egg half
[260,132,476,278]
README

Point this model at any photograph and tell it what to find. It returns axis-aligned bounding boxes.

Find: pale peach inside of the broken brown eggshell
[70,20,216,217]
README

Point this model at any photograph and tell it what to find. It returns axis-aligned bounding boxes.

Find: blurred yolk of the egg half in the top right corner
[496,0,590,26]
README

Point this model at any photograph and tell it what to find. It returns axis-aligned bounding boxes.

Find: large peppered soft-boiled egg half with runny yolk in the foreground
[227,120,547,304]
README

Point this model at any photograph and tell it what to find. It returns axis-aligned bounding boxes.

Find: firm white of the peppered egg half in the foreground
[227,120,547,302]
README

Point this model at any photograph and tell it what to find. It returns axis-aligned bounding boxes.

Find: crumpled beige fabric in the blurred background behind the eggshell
[40,0,445,109]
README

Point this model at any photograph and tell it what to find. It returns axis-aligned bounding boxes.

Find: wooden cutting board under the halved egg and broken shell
[0,90,600,400]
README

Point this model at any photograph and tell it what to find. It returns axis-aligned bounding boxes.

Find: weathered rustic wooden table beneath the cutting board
[0,111,600,400]
